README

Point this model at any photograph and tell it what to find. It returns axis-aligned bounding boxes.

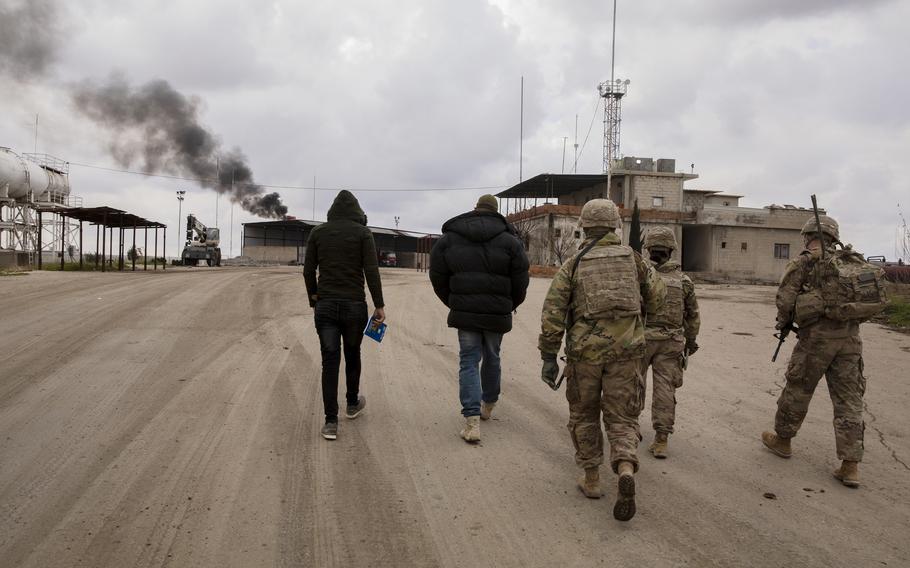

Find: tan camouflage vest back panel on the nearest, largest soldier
[573,245,641,320]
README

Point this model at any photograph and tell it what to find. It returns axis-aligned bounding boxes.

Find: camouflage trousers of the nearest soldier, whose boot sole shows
[566,358,645,472]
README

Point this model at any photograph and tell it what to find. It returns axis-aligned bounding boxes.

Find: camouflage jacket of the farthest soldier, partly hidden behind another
[645,260,701,341]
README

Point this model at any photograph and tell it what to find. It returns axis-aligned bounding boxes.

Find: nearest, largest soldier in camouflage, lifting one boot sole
[538,199,666,521]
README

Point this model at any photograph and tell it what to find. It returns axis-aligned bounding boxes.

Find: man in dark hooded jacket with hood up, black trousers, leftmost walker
[303,190,385,440]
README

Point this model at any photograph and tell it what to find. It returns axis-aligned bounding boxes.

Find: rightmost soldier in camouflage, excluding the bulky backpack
[762,215,884,487]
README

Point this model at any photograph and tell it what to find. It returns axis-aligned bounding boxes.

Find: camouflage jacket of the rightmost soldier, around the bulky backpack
[777,246,859,338]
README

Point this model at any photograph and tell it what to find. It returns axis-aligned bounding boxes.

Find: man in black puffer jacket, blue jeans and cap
[430,195,528,442]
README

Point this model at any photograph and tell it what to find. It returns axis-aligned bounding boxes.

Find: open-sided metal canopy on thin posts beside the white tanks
[36,206,167,272]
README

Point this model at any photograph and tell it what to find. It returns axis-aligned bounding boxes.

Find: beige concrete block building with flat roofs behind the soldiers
[497,157,813,282]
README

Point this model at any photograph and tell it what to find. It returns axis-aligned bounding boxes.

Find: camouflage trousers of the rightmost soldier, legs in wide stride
[774,335,866,461]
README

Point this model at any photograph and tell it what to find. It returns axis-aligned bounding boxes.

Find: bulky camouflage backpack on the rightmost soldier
[794,249,888,326]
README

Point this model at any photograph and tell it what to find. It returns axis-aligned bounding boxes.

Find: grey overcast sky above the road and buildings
[0,0,910,257]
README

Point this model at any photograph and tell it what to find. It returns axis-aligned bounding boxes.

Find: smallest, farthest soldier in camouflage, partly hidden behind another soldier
[641,227,700,459]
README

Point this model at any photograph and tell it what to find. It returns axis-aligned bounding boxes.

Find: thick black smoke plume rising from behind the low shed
[72,76,288,218]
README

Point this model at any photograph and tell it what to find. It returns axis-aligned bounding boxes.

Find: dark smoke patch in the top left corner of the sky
[0,0,62,79]
